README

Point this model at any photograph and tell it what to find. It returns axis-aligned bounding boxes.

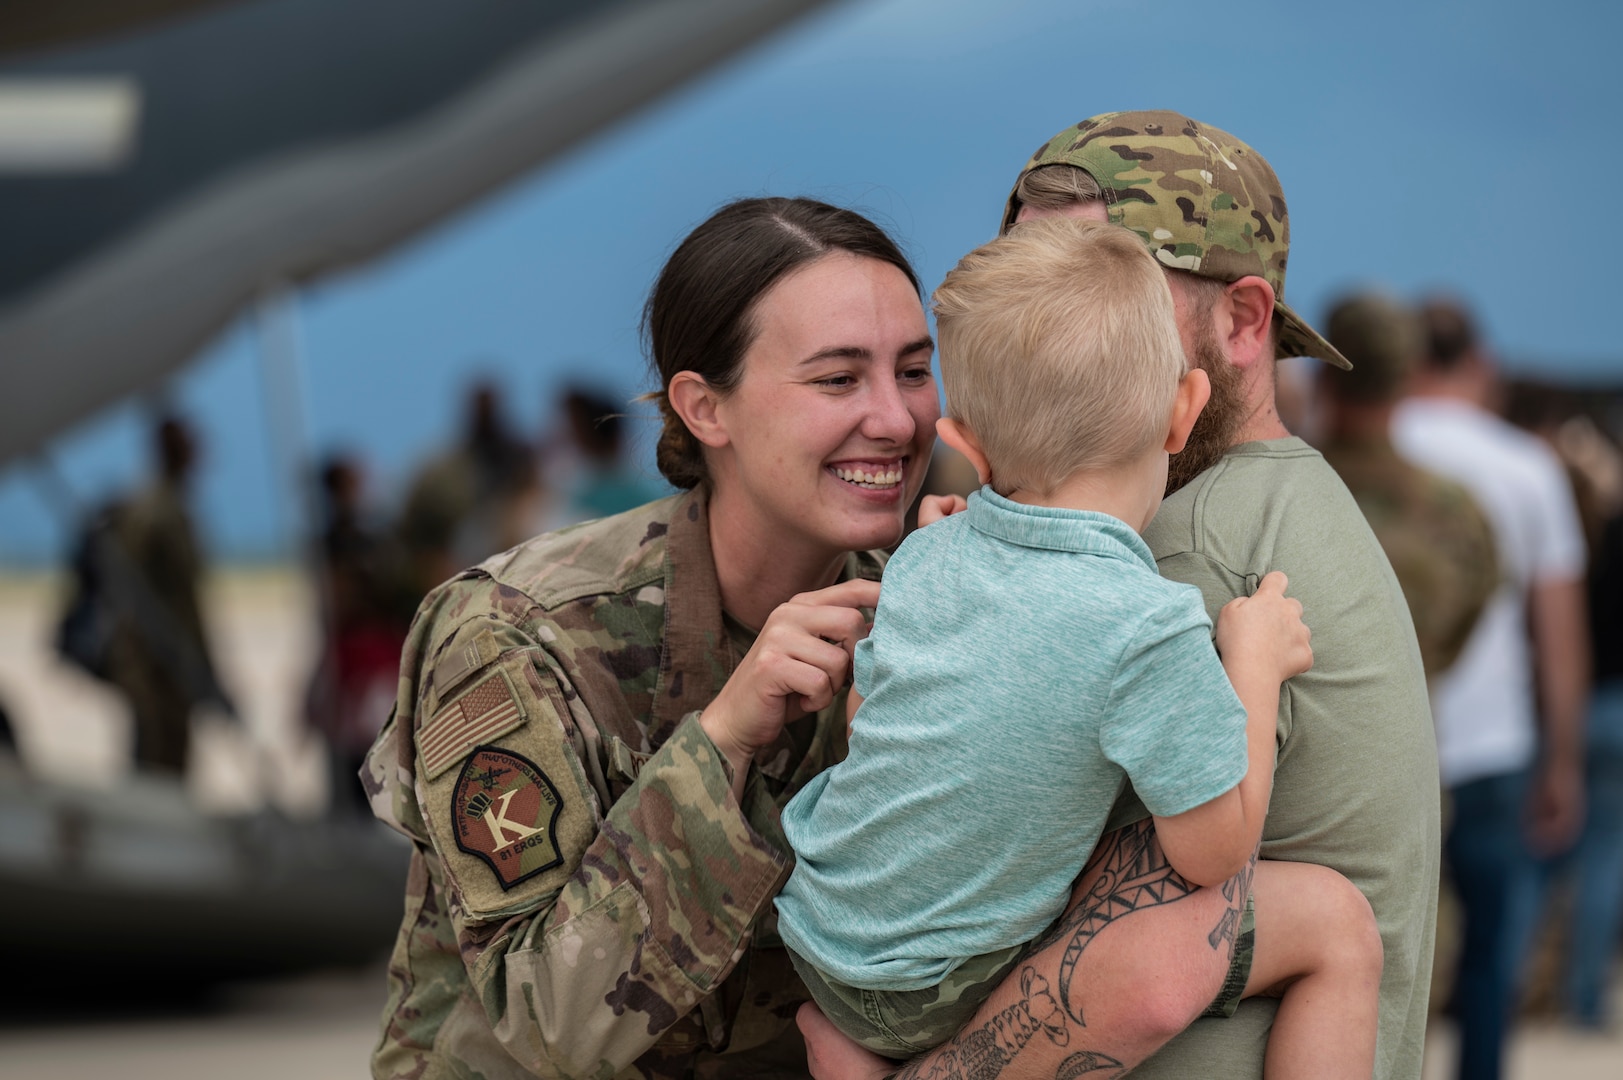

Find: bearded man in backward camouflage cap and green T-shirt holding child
[800,112,1438,1080]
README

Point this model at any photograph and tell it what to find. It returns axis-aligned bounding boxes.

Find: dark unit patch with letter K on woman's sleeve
[451,745,563,890]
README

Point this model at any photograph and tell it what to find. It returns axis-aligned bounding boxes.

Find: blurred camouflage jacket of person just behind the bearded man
[1324,438,1500,679]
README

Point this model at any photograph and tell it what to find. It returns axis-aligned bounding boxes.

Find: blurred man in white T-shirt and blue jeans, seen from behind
[1393,300,1589,1080]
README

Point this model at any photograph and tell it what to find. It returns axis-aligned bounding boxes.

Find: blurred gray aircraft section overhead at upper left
[0,0,824,463]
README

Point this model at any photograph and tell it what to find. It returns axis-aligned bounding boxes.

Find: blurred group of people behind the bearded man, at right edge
[1281,294,1623,1077]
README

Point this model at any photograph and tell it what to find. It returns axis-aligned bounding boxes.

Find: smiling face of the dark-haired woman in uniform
[708,252,940,555]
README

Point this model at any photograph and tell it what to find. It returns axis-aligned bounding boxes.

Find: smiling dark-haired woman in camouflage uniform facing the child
[364,200,938,1080]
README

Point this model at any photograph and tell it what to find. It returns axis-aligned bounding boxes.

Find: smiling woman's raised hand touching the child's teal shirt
[700,580,880,793]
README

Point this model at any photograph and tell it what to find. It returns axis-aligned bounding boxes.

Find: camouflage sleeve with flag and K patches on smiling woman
[373,577,790,1077]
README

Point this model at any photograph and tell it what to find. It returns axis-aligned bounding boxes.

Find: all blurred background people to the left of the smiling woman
[47,382,665,815]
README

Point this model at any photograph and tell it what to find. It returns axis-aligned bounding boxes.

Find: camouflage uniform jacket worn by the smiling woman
[364,494,880,1080]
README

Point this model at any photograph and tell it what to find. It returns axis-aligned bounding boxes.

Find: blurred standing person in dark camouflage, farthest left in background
[104,416,226,776]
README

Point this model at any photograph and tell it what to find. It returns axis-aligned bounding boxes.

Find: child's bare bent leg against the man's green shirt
[1245,859,1383,1080]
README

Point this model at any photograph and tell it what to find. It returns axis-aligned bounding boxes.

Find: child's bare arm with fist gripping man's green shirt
[1156,570,1313,885]
